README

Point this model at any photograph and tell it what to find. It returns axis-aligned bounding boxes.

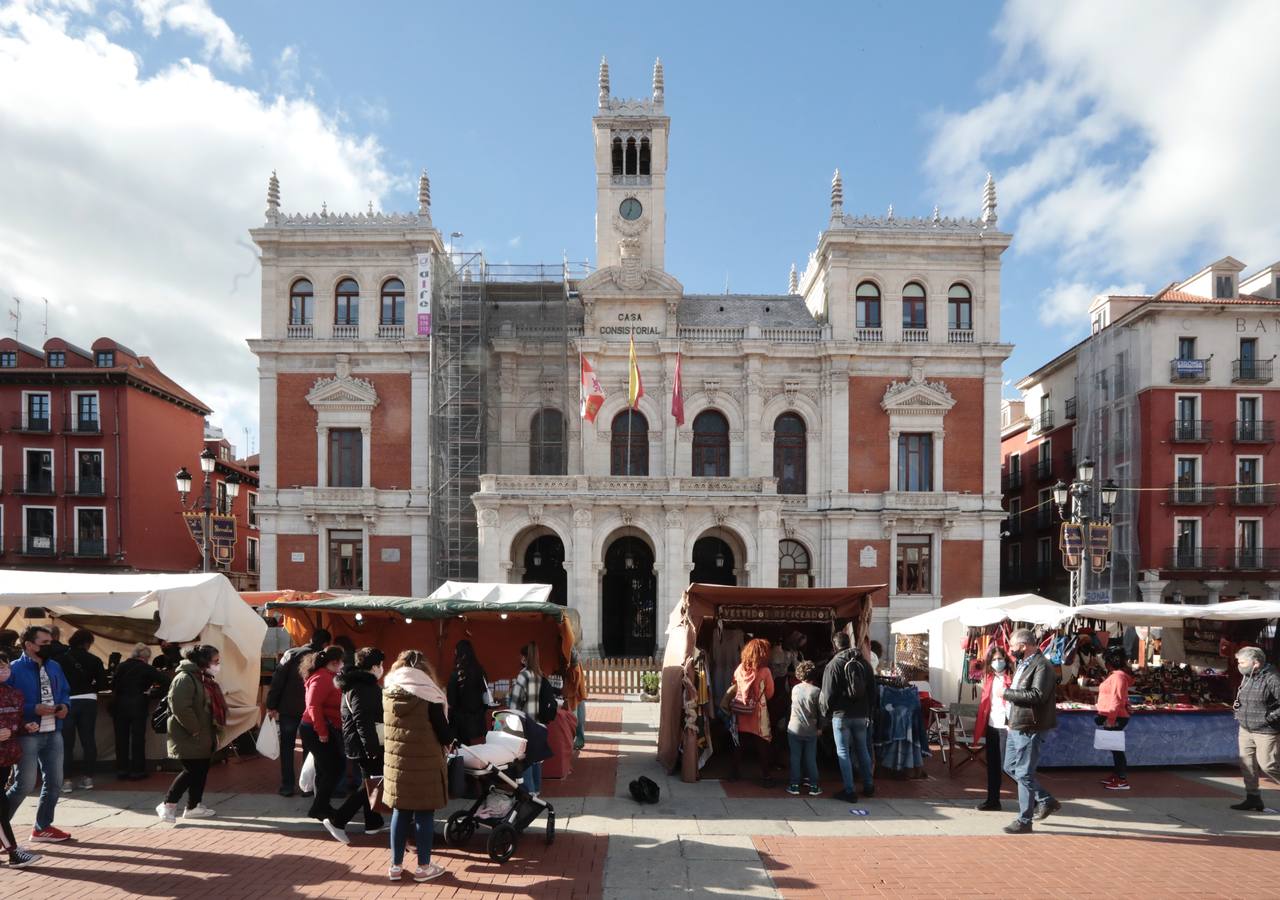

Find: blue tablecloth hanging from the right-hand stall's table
[1039,709,1239,767]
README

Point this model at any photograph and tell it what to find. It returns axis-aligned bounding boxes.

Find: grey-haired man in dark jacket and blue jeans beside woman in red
[1005,629,1062,835]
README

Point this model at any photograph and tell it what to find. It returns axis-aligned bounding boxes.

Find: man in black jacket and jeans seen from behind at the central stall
[818,631,876,803]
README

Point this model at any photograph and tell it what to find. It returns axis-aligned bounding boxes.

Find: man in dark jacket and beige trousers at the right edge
[1231,647,1280,813]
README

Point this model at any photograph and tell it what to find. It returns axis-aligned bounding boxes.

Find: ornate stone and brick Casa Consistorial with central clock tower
[251,61,1011,655]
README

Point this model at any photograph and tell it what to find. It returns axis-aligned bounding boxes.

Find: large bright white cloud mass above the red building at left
[0,6,392,448]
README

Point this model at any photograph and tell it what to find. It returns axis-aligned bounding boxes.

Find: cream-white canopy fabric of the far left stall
[0,570,266,746]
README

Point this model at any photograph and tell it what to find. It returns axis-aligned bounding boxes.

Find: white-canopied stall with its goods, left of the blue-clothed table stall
[890,594,1070,704]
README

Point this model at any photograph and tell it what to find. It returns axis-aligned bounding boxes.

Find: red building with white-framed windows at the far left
[0,338,209,572]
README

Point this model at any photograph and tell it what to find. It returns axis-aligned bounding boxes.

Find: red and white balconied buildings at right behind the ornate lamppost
[1001,256,1280,603]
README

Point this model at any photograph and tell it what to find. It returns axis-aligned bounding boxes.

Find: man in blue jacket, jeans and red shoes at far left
[8,625,72,842]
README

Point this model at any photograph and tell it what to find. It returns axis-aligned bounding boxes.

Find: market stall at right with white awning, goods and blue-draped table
[1039,600,1280,767]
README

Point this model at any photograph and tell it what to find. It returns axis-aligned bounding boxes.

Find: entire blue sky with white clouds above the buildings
[0,0,1280,440]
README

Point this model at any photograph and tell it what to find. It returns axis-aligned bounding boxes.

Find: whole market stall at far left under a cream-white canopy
[0,570,266,762]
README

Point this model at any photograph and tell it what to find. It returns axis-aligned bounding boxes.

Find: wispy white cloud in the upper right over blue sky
[925,0,1280,315]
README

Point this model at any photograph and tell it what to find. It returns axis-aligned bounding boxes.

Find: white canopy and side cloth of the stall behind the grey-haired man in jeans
[890,594,1071,703]
